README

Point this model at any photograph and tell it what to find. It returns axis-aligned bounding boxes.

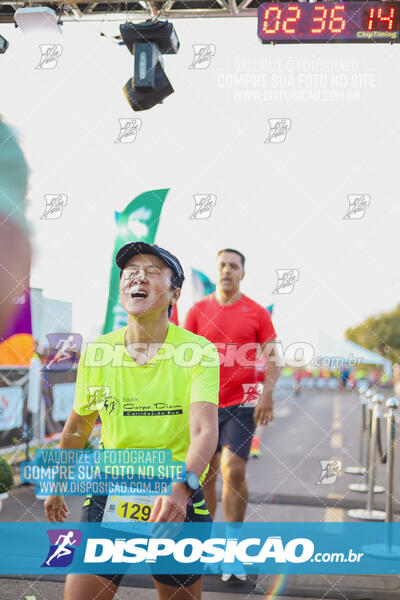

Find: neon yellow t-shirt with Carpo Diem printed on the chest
[74,323,219,472]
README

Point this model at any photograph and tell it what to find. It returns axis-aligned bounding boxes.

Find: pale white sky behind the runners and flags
[0,18,400,346]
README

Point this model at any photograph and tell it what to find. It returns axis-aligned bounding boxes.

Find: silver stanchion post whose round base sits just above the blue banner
[347,394,394,521]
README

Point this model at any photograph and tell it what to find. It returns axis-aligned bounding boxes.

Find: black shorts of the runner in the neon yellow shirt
[81,488,212,587]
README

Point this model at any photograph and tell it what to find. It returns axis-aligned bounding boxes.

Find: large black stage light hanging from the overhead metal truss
[120,21,179,111]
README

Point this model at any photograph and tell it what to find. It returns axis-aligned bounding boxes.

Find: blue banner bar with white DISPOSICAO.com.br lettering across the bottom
[0,522,400,575]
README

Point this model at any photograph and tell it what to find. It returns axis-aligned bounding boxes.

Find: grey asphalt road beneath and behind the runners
[0,390,400,600]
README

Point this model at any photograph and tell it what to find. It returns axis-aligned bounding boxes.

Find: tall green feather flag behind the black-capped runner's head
[103,189,169,333]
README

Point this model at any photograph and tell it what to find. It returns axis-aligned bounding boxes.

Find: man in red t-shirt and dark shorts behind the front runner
[185,248,280,581]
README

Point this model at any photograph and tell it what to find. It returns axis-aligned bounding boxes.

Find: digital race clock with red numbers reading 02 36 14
[258,1,400,44]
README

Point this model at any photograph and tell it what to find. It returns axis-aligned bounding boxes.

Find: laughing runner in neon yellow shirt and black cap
[45,242,219,600]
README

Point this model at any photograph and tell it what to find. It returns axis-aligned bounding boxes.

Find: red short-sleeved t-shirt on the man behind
[185,293,276,407]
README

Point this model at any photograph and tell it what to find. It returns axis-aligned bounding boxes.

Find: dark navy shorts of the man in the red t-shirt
[217,404,255,461]
